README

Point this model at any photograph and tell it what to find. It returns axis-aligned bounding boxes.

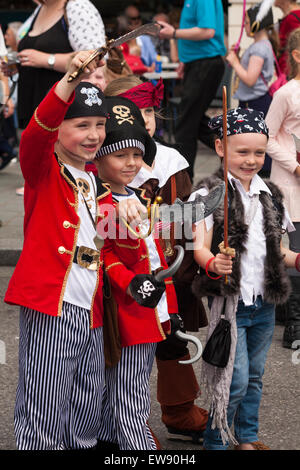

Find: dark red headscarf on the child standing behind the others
[119,78,164,109]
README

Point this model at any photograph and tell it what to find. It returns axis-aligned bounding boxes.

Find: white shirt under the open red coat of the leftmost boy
[64,165,97,310]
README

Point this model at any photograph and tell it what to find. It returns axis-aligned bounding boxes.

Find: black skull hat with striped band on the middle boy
[96,96,156,166]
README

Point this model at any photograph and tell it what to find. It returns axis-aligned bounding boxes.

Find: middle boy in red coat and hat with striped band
[95,97,178,450]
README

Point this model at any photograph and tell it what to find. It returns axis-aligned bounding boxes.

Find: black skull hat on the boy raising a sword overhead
[65,82,107,119]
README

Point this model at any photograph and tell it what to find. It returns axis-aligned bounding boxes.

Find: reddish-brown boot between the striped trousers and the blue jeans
[156,354,208,443]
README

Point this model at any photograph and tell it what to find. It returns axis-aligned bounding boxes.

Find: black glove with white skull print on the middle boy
[129,274,166,308]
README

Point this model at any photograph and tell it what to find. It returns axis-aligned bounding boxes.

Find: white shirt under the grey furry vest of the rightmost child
[189,172,295,305]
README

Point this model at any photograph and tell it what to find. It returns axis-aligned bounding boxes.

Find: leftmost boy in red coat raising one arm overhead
[5,51,118,450]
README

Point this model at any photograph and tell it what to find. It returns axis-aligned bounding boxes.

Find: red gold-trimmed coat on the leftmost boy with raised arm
[4,86,112,328]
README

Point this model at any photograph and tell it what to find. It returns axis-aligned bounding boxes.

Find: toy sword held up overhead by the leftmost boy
[68,22,162,82]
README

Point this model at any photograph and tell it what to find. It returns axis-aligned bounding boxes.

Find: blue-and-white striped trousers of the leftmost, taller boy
[15,302,104,450]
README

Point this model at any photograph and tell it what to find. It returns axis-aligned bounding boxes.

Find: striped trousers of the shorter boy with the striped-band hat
[99,343,156,450]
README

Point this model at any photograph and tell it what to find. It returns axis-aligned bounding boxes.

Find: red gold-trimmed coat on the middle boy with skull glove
[102,188,178,347]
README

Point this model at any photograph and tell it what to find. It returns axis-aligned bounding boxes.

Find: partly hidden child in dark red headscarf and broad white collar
[104,76,207,442]
